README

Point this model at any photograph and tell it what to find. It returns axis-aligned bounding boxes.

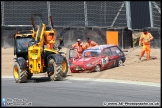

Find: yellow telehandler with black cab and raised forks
[13,16,68,83]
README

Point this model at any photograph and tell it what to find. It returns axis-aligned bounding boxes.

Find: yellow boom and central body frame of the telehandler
[28,23,59,74]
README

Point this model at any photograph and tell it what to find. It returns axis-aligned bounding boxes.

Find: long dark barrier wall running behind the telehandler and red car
[1,26,138,48]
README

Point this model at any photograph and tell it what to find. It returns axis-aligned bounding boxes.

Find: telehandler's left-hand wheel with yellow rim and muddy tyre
[13,62,28,83]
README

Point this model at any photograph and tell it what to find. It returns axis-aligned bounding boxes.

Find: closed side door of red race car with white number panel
[102,48,114,69]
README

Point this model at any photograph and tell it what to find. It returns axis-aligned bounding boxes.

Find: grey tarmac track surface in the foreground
[2,78,161,106]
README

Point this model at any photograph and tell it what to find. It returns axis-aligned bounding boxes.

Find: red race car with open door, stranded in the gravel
[69,45,126,73]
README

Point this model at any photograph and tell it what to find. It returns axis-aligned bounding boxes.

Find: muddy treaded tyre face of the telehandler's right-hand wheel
[48,58,62,81]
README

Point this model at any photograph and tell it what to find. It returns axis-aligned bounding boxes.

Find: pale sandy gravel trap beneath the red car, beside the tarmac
[1,48,161,83]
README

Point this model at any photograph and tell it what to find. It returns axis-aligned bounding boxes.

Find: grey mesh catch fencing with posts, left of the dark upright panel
[1,1,127,27]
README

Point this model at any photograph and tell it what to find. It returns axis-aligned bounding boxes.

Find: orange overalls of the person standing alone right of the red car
[139,33,154,60]
